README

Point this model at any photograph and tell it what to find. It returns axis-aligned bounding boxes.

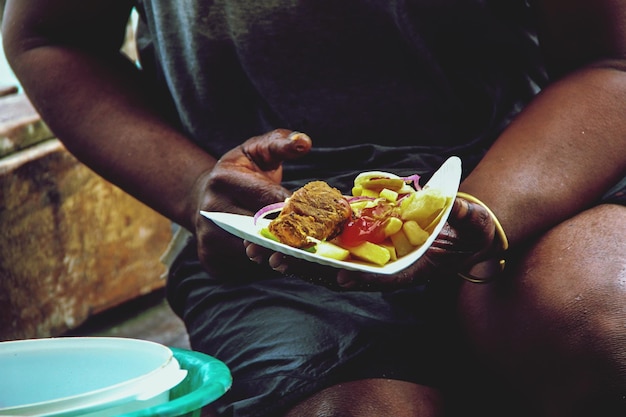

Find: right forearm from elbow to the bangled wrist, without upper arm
[461,60,626,244]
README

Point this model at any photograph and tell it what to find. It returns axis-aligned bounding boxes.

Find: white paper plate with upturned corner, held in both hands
[200,156,461,274]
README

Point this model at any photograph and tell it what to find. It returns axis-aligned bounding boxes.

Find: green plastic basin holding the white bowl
[122,348,232,417]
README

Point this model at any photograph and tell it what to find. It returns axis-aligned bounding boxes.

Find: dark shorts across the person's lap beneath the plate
[168,243,452,417]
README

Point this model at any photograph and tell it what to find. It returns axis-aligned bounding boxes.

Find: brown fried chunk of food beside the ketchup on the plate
[269,181,352,248]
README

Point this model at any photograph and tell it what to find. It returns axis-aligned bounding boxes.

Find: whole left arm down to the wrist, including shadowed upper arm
[3,0,215,230]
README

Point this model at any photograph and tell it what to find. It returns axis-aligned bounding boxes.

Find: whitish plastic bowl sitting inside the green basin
[0,337,187,417]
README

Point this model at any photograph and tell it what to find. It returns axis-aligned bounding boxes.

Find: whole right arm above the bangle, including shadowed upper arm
[461,0,626,244]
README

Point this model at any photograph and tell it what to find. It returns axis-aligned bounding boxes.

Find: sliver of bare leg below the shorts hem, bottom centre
[285,379,443,417]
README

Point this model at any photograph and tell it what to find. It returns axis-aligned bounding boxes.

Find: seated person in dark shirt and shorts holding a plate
[3,0,626,417]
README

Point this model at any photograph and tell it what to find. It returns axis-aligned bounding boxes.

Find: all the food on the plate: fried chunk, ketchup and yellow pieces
[255,171,452,266]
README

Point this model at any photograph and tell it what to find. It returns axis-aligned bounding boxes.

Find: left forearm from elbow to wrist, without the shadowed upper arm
[4,46,215,228]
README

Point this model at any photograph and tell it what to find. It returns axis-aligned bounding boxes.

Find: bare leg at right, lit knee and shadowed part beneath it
[461,205,626,417]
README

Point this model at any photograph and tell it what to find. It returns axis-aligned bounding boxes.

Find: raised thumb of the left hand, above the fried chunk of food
[241,129,312,171]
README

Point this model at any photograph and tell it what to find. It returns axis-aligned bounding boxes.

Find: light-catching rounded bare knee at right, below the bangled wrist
[512,205,626,348]
